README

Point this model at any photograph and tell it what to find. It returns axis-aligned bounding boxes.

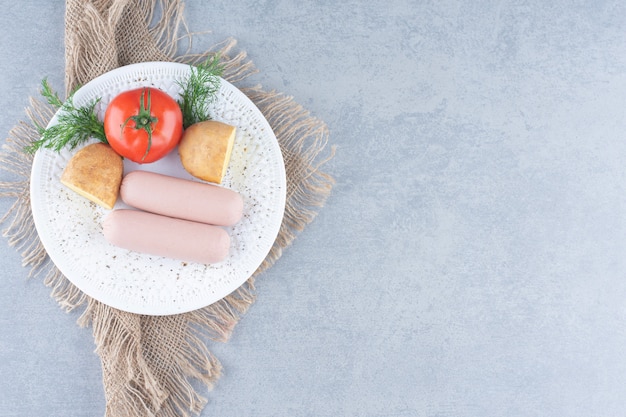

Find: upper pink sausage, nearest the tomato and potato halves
[120,171,243,226]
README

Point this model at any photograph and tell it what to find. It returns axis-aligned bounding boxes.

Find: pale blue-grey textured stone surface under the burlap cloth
[0,0,626,417]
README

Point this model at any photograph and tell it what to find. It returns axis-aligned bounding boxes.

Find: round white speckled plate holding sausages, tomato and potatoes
[31,62,286,315]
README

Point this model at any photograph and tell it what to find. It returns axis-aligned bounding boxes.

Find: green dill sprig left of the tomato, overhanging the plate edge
[24,78,108,154]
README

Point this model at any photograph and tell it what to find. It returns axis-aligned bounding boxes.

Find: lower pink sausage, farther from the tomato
[103,210,230,264]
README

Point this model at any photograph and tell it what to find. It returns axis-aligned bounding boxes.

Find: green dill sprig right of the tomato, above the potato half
[177,54,224,129]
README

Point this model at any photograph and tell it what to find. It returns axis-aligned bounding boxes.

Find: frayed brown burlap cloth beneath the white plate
[0,0,333,417]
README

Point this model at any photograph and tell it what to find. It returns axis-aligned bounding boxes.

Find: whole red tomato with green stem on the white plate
[104,87,183,164]
